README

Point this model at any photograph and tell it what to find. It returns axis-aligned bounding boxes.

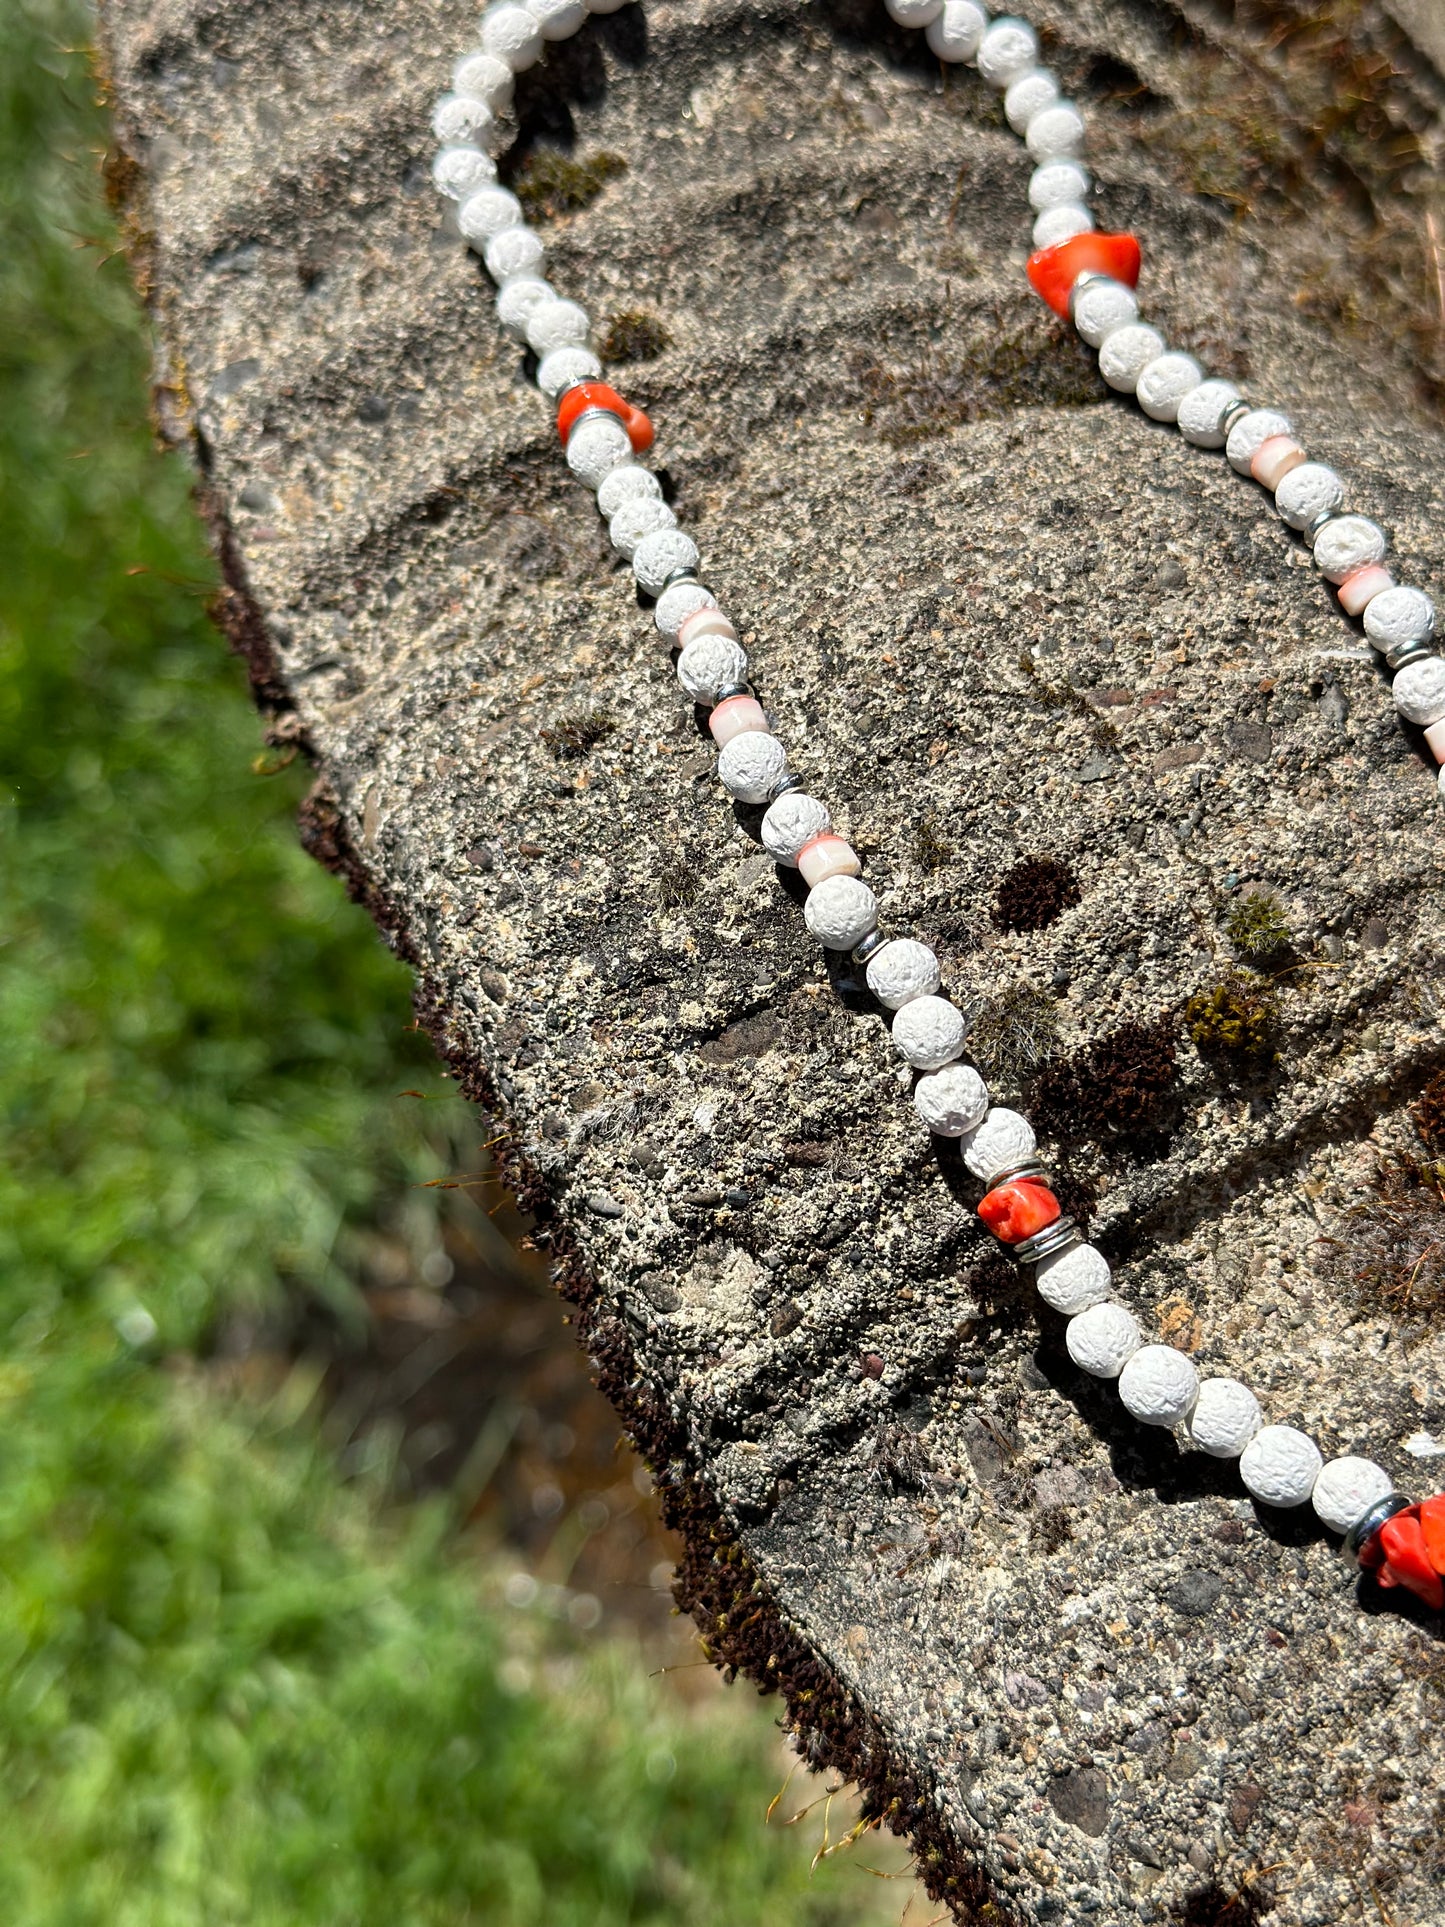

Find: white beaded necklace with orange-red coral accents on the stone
[432,0,1445,1611]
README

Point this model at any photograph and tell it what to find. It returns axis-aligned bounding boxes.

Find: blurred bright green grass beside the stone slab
[0,0,898,1927]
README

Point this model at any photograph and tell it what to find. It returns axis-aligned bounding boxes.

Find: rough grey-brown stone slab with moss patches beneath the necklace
[106,0,1445,1927]
